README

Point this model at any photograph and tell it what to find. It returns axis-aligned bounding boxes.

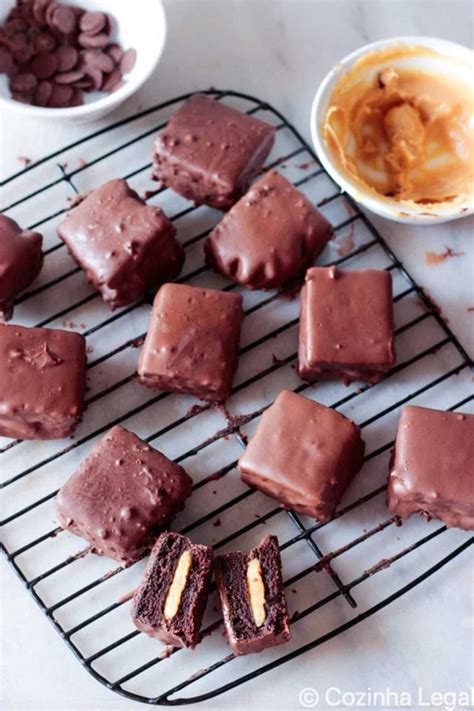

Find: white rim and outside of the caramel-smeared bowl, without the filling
[311,37,474,224]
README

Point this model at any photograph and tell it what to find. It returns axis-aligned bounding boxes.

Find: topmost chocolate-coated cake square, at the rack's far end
[153,94,275,209]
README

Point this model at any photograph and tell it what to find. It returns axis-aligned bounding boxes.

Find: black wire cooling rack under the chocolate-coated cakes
[0,90,474,705]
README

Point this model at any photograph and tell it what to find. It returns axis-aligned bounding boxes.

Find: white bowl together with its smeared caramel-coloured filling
[311,37,474,224]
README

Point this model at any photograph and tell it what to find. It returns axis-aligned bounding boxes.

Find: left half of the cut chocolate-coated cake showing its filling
[132,532,213,647]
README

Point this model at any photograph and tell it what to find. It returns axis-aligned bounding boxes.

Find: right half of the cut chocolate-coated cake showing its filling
[215,536,290,655]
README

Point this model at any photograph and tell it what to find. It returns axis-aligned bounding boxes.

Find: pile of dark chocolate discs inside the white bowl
[0,0,136,108]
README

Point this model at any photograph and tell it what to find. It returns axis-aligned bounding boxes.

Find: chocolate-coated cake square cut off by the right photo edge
[388,405,474,531]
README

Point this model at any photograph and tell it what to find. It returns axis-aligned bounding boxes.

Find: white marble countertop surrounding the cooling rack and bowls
[0,0,474,711]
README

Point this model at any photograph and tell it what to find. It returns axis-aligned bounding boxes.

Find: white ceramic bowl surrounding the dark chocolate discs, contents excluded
[0,0,166,123]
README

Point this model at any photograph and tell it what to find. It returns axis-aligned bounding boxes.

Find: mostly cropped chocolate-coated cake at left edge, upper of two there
[0,214,43,321]
